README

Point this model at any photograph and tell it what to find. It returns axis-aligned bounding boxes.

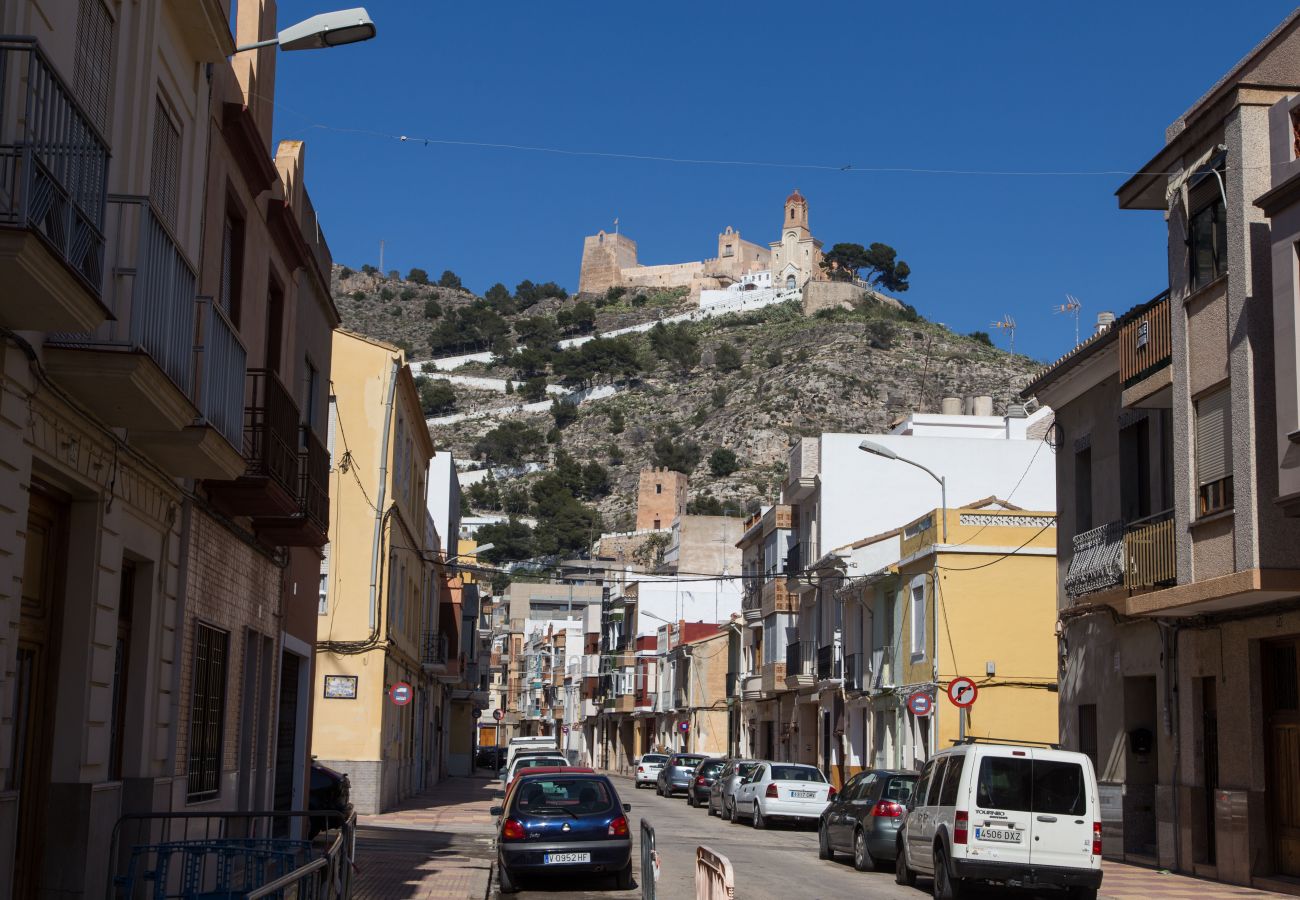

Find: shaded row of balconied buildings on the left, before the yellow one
[0,0,338,897]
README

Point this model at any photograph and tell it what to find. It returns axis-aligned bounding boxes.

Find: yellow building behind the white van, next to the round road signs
[893,507,1058,758]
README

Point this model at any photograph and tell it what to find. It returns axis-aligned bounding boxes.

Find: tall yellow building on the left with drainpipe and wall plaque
[312,330,442,813]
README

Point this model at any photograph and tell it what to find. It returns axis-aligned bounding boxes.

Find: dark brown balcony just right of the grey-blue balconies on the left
[207,369,301,519]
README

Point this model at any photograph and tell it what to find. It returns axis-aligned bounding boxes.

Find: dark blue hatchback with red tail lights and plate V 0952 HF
[491,771,632,893]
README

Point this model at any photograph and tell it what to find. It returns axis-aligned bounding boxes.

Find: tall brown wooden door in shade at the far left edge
[14,489,66,900]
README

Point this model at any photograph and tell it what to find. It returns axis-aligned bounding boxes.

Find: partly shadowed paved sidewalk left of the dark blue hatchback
[352,775,498,900]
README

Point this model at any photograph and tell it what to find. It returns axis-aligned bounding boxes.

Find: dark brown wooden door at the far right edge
[1264,637,1300,877]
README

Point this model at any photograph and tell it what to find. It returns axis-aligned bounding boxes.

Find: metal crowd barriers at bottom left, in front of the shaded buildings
[107,810,356,900]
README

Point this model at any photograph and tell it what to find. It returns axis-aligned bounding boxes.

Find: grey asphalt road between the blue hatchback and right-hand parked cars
[491,778,1045,900]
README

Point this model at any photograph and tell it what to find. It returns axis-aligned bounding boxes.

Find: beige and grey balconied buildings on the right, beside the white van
[1027,13,1300,892]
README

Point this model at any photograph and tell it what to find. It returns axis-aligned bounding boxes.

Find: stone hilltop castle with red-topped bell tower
[579,190,823,298]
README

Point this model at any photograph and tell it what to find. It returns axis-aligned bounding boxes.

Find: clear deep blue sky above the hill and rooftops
[276,0,1291,359]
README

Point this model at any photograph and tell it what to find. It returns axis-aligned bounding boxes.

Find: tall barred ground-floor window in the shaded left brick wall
[186,622,230,802]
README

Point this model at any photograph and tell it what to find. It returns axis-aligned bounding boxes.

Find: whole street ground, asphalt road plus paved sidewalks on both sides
[355,775,1300,900]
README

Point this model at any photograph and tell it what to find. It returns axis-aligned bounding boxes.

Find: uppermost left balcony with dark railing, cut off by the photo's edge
[0,38,110,332]
